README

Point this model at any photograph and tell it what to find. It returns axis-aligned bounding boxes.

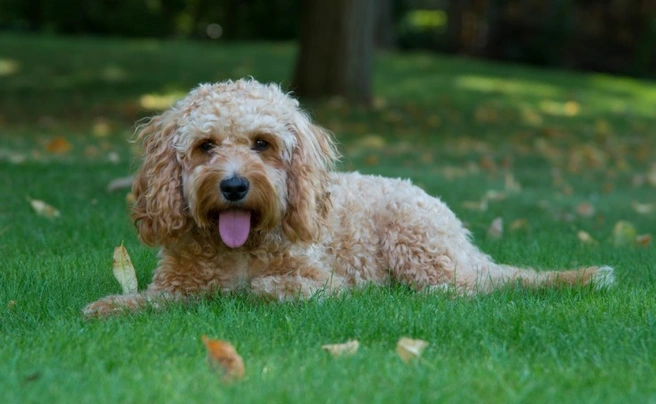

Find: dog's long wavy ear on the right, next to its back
[282,111,339,242]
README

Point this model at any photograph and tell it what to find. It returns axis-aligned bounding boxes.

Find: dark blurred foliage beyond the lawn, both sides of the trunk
[0,0,656,77]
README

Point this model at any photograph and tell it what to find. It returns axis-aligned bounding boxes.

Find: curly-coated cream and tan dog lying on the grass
[84,80,614,316]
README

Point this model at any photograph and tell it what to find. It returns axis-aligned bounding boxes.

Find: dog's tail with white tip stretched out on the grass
[468,264,615,292]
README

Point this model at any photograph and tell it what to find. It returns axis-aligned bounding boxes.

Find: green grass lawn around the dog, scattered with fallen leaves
[0,35,656,403]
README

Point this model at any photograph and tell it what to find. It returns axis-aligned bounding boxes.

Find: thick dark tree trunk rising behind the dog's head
[292,0,376,104]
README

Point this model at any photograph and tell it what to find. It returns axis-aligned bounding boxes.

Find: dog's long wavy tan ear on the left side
[132,112,190,246]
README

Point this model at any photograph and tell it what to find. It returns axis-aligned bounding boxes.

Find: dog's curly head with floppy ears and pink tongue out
[132,80,338,248]
